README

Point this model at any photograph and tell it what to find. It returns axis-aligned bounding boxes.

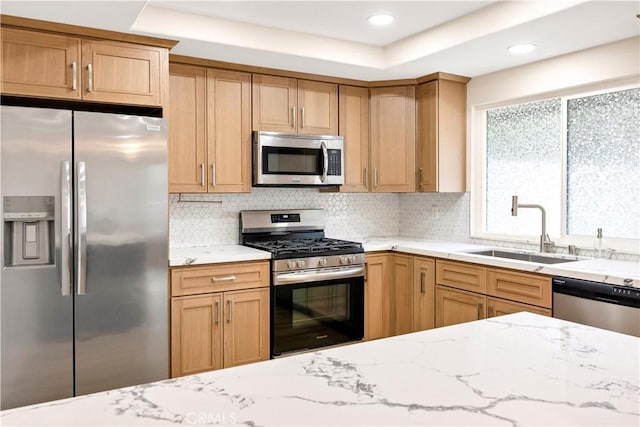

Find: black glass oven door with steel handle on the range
[271,267,364,357]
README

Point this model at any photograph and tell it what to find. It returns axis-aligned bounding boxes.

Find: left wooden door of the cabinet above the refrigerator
[0,28,82,99]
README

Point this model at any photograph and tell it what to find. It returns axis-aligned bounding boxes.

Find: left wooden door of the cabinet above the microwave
[252,74,298,133]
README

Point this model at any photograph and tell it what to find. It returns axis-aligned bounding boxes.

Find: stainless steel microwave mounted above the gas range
[253,131,344,187]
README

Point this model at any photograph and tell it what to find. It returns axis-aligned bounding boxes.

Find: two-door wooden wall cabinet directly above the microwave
[252,74,338,135]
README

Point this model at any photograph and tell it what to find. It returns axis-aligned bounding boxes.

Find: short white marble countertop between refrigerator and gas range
[169,245,271,267]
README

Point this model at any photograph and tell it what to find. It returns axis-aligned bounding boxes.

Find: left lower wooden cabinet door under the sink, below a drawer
[436,286,486,328]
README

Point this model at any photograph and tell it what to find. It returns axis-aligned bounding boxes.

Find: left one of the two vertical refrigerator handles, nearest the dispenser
[60,160,71,296]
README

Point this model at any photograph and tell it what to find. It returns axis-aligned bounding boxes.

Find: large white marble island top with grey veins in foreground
[0,313,640,426]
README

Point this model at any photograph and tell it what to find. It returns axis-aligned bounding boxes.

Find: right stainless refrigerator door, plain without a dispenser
[74,112,169,395]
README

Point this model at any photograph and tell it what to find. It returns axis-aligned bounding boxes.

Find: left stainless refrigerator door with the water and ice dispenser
[0,106,73,409]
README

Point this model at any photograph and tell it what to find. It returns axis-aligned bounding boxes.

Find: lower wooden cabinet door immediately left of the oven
[224,288,269,368]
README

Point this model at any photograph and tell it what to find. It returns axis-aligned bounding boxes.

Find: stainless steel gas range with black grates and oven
[240,209,364,357]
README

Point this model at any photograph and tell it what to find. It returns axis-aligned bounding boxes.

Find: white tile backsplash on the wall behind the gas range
[169,187,400,247]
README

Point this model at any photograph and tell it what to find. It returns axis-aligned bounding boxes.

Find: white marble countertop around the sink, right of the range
[363,238,640,288]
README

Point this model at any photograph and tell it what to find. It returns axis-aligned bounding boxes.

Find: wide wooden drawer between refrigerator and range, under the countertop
[171,261,269,296]
